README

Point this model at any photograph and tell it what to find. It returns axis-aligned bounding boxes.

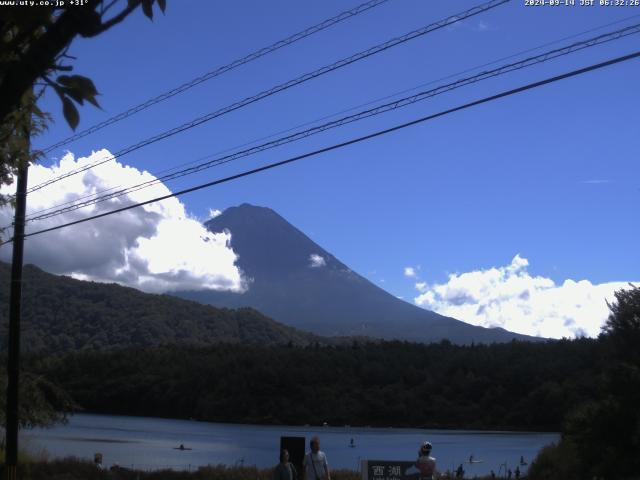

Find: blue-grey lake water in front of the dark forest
[20,414,559,476]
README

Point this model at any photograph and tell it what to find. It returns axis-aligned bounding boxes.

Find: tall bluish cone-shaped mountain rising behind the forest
[177,203,540,344]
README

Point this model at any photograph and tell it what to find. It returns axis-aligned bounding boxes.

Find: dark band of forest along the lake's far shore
[29,339,600,431]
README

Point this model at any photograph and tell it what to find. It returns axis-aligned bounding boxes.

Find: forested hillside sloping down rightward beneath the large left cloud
[0,262,326,352]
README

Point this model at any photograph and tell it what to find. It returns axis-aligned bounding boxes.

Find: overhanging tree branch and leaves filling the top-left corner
[0,0,166,218]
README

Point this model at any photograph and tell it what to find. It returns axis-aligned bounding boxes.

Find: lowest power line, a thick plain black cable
[0,51,640,246]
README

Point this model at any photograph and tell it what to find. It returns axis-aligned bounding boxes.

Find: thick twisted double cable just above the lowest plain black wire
[22,23,640,222]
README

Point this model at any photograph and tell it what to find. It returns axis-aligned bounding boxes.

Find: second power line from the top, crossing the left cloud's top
[27,0,511,193]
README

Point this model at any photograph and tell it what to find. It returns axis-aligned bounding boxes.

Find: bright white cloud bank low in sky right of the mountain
[414,255,628,338]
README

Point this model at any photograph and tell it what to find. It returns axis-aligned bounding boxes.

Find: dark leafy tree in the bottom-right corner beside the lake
[530,285,640,480]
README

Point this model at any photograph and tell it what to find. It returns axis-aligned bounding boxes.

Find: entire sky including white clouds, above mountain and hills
[0,0,640,338]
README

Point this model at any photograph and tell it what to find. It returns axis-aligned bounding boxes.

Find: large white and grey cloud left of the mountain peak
[0,150,244,292]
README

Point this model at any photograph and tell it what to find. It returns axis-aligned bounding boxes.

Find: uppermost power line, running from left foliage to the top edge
[43,0,389,153]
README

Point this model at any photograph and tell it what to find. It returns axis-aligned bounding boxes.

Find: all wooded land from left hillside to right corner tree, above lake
[0,264,640,480]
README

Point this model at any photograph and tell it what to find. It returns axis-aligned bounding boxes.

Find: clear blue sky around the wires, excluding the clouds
[6,0,640,338]
